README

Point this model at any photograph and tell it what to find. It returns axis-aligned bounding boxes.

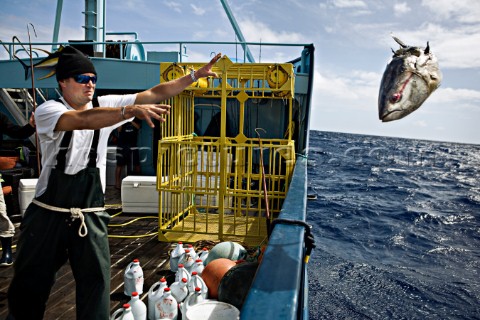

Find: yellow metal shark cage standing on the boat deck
[157,56,295,245]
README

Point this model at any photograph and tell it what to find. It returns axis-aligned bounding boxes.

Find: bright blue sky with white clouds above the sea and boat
[0,0,480,144]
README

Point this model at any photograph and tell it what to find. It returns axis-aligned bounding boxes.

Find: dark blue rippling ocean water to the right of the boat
[308,131,480,319]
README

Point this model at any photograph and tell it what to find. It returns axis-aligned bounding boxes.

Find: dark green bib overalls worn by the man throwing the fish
[8,126,110,320]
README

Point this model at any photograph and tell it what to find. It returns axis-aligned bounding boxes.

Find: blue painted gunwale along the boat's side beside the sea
[240,157,308,319]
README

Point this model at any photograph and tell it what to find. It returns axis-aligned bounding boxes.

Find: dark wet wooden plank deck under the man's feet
[0,187,173,320]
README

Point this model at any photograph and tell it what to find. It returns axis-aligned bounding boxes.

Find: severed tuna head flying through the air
[378,37,442,122]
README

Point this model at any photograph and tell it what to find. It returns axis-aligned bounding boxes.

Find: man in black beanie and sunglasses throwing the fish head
[8,47,220,320]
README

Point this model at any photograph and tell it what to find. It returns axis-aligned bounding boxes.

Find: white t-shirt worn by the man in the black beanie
[35,94,137,197]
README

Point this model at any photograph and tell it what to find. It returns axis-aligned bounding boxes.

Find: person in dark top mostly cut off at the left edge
[0,113,35,267]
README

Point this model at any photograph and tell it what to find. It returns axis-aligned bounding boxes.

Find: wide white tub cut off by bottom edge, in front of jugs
[183,300,240,320]
